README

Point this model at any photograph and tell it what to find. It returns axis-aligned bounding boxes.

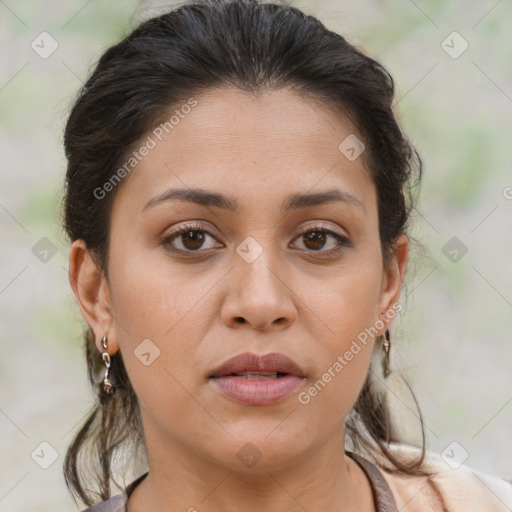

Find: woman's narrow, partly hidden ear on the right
[378,234,409,334]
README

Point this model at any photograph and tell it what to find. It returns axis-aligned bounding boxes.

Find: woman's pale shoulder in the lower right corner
[375,443,512,512]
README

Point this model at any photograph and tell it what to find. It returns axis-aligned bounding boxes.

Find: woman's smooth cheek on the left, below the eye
[110,248,218,400]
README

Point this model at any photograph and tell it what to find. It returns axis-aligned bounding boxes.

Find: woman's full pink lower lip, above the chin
[211,375,303,405]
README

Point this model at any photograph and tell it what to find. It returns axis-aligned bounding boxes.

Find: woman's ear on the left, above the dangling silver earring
[68,240,119,355]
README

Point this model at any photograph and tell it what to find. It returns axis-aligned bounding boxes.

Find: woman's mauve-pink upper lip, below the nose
[210,352,305,377]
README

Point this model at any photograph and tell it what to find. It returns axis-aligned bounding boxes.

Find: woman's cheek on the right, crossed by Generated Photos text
[298,261,381,418]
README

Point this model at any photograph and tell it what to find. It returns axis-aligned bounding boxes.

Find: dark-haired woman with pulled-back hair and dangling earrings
[64,0,512,512]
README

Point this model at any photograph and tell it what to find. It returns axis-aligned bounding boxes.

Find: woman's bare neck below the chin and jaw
[128,432,375,512]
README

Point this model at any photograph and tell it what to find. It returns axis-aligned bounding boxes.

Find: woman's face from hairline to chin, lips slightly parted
[73,89,407,471]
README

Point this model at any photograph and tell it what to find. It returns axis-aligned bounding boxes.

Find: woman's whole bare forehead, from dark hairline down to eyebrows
[113,89,373,215]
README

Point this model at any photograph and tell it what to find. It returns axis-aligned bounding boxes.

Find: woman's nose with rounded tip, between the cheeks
[221,250,297,331]
